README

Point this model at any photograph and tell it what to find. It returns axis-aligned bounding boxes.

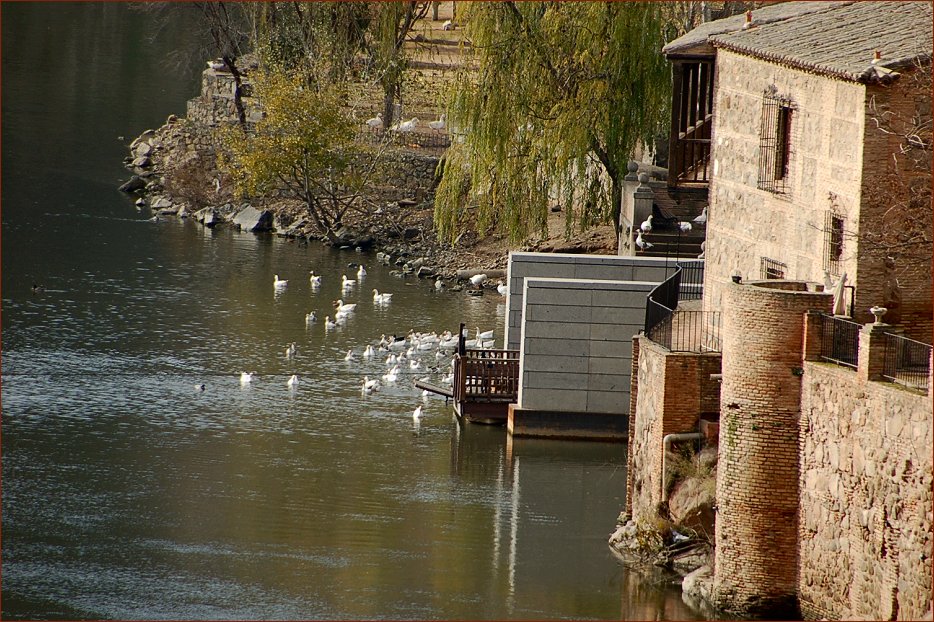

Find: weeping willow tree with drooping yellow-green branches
[435,2,671,246]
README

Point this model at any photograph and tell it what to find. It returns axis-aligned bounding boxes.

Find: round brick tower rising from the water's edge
[713,280,833,617]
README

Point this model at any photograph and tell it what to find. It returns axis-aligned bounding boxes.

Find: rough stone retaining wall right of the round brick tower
[798,362,934,620]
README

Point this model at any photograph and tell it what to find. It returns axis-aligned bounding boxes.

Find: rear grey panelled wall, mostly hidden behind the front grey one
[505,252,675,350]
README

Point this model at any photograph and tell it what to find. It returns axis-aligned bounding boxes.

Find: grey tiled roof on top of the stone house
[709,2,934,82]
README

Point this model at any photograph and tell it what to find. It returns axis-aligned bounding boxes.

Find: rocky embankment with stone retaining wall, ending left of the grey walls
[120,115,507,288]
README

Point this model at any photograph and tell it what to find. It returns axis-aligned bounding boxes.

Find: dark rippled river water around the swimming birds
[2,3,697,619]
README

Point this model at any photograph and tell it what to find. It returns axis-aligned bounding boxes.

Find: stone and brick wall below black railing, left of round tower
[626,335,720,523]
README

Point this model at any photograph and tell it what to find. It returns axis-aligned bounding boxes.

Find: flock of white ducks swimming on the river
[229,265,506,427]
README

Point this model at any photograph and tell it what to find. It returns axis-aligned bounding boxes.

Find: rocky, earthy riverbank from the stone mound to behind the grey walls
[121,115,616,287]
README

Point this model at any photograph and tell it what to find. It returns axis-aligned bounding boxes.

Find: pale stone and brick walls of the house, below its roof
[704,49,932,343]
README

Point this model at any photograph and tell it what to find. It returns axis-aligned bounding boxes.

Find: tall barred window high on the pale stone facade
[758,87,795,194]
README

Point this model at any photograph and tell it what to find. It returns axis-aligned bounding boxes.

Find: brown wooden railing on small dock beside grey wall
[454,350,519,403]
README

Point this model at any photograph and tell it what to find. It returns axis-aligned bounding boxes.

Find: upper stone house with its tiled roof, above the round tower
[680,2,932,343]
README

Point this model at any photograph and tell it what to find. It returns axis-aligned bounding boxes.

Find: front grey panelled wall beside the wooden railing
[518,278,655,415]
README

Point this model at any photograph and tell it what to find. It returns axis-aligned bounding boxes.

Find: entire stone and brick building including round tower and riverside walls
[627,2,934,619]
